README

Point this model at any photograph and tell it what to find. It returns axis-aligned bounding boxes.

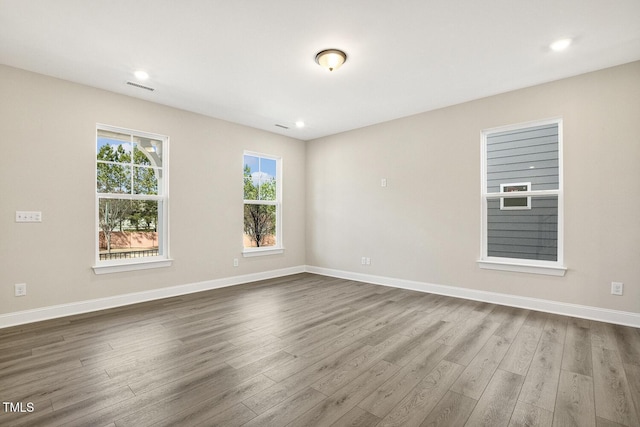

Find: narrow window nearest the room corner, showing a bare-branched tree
[243,152,282,256]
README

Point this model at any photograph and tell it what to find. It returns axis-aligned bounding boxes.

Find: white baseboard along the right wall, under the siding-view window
[306,265,640,328]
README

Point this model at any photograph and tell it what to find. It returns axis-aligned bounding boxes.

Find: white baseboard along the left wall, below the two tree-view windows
[0,266,306,329]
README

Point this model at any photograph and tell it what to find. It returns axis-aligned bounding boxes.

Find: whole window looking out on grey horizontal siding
[479,120,566,275]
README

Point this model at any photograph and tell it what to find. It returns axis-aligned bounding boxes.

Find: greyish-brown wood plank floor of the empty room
[0,274,640,427]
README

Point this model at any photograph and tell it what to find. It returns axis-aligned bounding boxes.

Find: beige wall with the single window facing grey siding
[306,62,640,313]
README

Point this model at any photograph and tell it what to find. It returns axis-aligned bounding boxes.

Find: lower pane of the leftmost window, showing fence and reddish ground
[98,198,162,261]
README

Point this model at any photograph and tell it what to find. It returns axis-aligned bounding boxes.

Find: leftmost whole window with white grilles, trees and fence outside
[94,125,170,274]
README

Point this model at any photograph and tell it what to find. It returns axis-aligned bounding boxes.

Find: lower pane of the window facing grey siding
[487,196,558,261]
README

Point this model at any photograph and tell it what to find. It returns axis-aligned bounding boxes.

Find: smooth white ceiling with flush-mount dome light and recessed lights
[0,0,640,140]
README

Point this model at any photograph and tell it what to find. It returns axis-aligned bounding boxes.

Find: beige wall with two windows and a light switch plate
[0,66,305,314]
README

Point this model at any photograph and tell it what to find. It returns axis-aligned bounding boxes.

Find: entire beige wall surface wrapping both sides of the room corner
[0,62,640,320]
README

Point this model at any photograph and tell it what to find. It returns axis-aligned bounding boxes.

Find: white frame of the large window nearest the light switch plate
[92,123,173,274]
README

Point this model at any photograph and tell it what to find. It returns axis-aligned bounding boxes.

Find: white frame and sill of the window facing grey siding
[477,118,567,276]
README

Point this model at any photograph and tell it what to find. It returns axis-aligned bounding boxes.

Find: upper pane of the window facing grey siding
[487,123,560,193]
